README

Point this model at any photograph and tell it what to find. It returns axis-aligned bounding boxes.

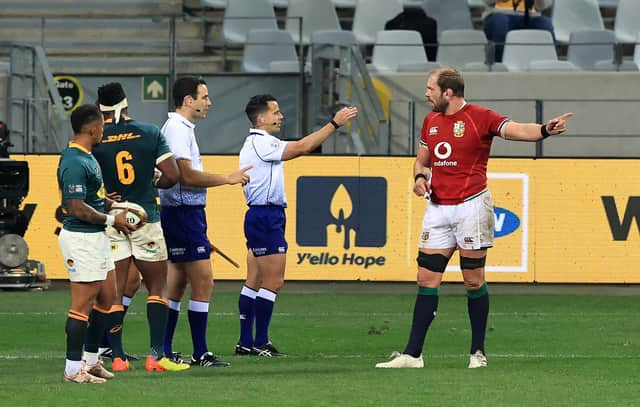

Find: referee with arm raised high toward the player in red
[235,95,358,357]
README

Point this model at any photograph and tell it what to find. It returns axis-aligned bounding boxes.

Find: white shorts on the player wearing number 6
[107,222,167,262]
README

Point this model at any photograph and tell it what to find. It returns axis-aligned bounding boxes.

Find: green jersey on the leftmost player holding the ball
[58,143,105,232]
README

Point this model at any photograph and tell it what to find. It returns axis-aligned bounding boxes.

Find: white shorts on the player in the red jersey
[418,190,495,250]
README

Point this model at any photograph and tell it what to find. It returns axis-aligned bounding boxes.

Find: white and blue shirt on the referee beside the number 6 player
[158,112,207,206]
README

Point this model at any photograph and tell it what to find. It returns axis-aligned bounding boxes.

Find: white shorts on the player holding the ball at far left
[58,229,115,282]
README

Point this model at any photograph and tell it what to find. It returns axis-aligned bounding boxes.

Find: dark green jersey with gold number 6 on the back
[93,116,172,222]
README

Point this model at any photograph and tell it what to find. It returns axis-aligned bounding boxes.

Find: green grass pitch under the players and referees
[0,283,640,406]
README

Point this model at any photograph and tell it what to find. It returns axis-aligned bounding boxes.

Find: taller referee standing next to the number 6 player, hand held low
[159,76,249,367]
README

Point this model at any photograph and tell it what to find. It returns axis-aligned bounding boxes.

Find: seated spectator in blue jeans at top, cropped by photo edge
[482,0,555,62]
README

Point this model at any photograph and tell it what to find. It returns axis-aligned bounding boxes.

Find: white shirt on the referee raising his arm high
[240,129,287,207]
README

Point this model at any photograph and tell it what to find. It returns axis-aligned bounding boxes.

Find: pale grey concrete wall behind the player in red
[377,72,640,157]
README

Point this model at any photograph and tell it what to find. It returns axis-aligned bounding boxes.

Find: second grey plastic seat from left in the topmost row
[285,0,341,45]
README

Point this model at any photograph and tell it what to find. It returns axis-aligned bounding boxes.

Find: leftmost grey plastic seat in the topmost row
[222,0,278,44]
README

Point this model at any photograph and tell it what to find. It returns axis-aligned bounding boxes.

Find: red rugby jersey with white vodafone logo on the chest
[420,103,509,205]
